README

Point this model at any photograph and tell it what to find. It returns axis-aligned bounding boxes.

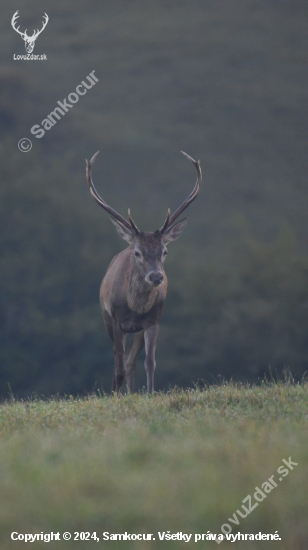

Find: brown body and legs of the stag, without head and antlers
[100,246,167,392]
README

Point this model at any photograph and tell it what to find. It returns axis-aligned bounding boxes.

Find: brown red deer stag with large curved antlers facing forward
[86,151,202,393]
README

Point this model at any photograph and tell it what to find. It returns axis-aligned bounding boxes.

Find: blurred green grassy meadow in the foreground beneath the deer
[0,381,308,550]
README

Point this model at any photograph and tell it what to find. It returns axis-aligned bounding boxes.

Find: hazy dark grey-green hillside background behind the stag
[0,0,308,398]
